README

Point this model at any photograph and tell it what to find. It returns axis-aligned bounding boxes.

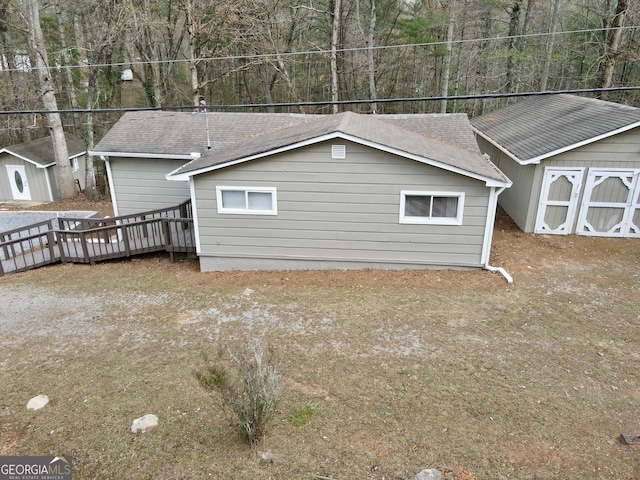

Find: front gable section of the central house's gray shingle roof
[172,112,506,182]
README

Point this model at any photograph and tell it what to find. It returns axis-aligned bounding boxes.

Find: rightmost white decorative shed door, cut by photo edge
[576,168,640,237]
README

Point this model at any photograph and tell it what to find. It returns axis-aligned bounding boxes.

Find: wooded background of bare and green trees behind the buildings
[0,0,640,198]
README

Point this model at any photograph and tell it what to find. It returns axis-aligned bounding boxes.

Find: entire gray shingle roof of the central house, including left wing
[94,112,505,181]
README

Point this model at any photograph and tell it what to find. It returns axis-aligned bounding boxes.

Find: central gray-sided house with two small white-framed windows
[92,112,511,271]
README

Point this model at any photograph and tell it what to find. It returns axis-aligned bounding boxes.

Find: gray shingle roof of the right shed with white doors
[471,94,640,162]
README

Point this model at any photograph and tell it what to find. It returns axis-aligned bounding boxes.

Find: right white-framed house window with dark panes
[400,190,464,225]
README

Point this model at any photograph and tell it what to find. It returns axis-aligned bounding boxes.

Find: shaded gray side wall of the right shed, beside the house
[477,137,539,231]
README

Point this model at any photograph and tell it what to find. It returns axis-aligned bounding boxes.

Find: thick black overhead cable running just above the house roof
[0,85,640,115]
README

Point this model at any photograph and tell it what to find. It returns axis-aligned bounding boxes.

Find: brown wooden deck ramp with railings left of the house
[0,201,196,275]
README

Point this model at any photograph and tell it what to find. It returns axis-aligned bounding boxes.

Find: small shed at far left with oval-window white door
[0,135,86,202]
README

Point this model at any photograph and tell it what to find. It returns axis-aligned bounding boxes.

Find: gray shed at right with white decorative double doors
[471,94,640,237]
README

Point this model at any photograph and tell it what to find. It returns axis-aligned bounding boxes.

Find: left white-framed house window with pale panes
[216,187,278,215]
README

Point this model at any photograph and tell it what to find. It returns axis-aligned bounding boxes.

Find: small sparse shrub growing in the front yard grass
[195,345,280,445]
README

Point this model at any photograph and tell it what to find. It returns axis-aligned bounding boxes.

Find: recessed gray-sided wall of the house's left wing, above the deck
[110,157,190,215]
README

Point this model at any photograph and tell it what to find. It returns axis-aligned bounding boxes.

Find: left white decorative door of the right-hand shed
[534,167,584,235]
